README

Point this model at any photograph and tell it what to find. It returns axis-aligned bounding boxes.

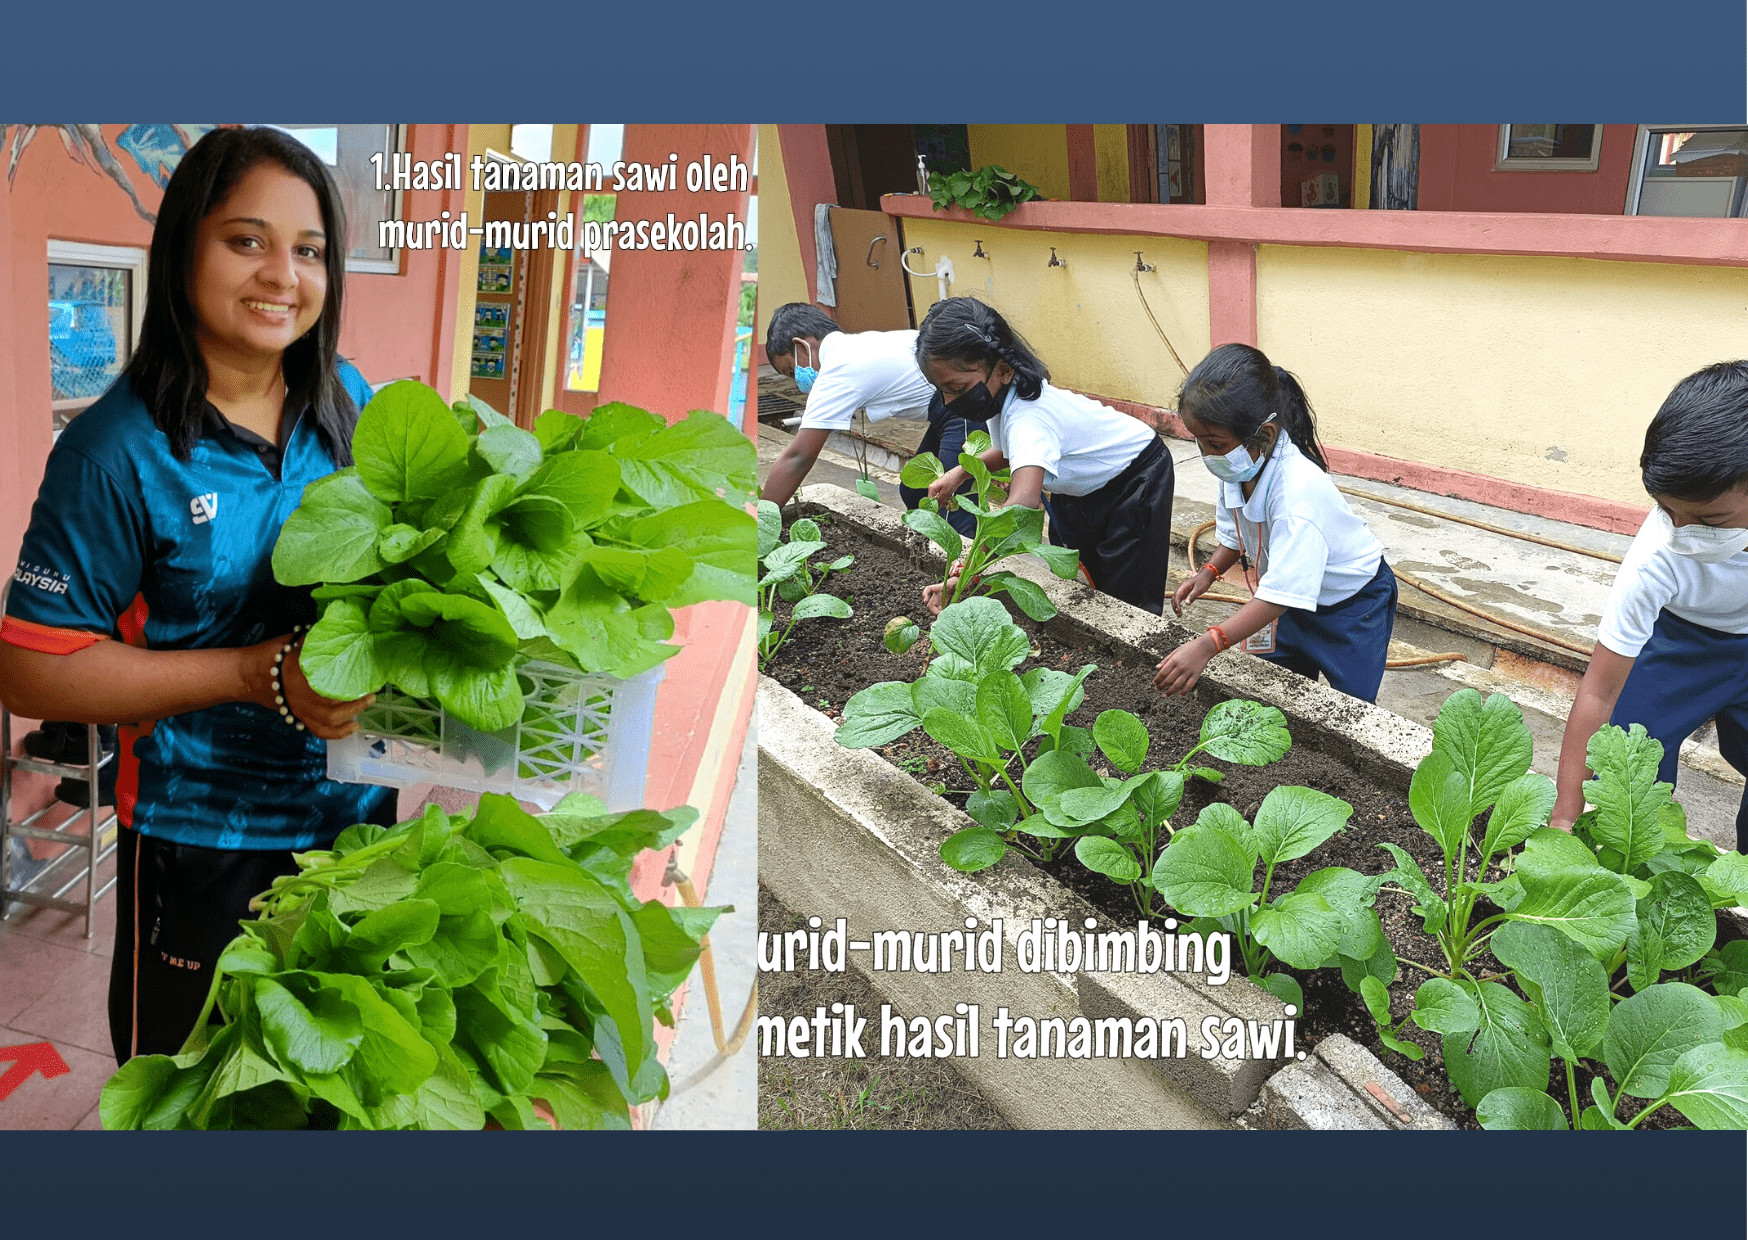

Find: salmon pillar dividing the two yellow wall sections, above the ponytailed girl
[1203,124,1281,345]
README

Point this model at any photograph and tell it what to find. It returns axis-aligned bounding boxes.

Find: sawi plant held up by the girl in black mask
[898,430,1080,621]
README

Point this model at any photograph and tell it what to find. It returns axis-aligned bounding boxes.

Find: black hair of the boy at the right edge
[1640,362,1748,502]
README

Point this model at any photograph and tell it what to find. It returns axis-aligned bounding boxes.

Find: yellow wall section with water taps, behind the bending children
[904,219,1210,408]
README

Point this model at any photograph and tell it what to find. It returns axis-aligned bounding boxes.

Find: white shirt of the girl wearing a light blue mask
[1213,434,1384,610]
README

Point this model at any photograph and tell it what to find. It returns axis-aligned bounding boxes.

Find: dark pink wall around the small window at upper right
[1419,124,1638,215]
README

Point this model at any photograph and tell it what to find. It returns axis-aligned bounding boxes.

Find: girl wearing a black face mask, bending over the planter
[916,297,1173,616]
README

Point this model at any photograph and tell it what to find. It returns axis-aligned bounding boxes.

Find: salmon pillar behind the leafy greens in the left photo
[601,124,755,930]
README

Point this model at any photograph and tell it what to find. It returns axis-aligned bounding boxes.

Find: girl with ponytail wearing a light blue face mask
[1154,345,1397,701]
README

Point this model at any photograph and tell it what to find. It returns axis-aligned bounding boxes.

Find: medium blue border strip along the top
[0,0,1748,124]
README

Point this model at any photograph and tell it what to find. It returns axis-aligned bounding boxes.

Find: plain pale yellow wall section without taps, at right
[1257,245,1748,504]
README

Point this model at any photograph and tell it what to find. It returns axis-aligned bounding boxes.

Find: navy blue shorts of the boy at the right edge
[1608,612,1748,852]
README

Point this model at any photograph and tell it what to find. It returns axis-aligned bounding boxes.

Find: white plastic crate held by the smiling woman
[329,663,668,813]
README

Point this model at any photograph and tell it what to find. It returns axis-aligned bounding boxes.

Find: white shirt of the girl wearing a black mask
[989,383,1157,495]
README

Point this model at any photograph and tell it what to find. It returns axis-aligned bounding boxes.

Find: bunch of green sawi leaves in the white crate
[273,381,757,731]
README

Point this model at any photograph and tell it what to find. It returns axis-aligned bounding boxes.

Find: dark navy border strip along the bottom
[0,1132,1745,1240]
